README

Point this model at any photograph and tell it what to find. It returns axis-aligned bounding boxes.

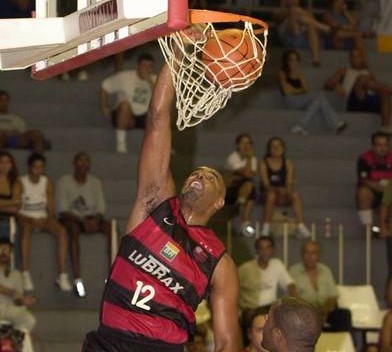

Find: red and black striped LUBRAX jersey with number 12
[99,197,225,344]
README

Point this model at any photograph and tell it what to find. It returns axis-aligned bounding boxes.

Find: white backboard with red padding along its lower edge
[0,0,188,79]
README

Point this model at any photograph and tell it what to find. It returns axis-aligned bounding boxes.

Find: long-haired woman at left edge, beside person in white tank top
[0,151,22,238]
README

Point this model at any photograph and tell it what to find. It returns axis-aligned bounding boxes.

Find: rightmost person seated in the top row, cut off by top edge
[323,0,364,50]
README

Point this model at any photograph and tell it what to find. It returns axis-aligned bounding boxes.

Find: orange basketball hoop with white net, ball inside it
[158,10,268,130]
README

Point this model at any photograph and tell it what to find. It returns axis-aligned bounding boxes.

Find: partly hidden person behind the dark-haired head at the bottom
[240,308,268,352]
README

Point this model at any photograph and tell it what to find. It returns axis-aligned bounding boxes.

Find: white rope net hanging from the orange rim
[158,10,268,131]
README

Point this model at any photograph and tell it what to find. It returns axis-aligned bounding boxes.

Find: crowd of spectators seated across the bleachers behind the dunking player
[0,0,392,352]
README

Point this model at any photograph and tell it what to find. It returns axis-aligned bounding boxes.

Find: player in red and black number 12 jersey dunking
[82,59,239,352]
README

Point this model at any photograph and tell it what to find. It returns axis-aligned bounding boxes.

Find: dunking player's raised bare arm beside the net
[127,64,175,232]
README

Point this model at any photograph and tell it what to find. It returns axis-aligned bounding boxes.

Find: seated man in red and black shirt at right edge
[356,132,392,226]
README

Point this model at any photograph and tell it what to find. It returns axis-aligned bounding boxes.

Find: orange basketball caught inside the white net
[202,29,262,88]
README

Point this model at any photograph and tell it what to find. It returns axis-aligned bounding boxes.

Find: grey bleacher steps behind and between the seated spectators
[0,31,392,352]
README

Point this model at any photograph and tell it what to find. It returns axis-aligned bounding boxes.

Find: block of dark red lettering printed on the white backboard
[79,0,118,33]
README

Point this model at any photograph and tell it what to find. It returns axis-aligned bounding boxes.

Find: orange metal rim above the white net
[189,10,268,34]
